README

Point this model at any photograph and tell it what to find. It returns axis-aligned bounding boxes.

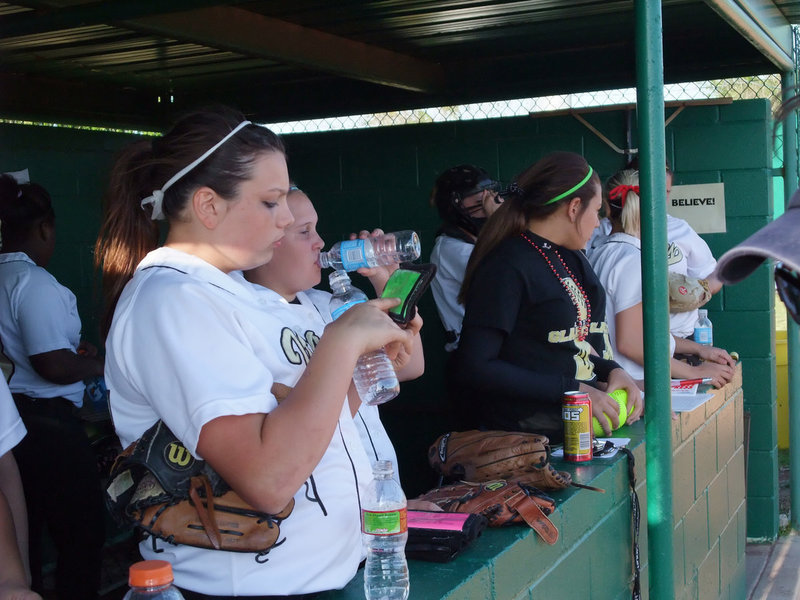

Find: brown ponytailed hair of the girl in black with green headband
[458,152,600,304]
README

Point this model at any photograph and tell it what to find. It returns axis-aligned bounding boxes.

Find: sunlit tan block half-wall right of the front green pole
[672,365,748,600]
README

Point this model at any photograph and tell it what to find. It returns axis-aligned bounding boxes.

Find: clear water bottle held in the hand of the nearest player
[328,271,400,406]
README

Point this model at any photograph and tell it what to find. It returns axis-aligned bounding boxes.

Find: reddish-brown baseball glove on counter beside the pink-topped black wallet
[417,479,558,544]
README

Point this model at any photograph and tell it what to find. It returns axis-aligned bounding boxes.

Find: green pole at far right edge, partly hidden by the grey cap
[783,71,800,530]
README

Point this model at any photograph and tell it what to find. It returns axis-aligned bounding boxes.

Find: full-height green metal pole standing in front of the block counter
[635,0,675,600]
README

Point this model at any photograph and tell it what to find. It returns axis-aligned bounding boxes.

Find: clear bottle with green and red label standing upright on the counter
[361,460,409,600]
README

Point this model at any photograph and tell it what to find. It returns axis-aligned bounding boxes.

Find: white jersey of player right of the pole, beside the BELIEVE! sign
[667,214,717,337]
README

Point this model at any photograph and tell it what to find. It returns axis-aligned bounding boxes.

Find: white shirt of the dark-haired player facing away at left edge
[0,252,85,406]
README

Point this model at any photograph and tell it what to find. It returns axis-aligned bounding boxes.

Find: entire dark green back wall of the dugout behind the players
[0,100,777,539]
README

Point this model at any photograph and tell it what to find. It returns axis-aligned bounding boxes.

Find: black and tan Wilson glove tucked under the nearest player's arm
[106,421,294,562]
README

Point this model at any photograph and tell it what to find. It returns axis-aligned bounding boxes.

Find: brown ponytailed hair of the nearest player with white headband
[95,107,285,336]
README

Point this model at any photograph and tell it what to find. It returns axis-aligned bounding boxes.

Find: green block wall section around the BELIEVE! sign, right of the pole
[667,100,778,541]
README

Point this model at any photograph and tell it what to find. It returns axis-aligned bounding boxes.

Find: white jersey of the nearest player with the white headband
[106,248,363,596]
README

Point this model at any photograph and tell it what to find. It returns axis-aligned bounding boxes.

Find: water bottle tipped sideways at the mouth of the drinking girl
[319,231,420,271]
